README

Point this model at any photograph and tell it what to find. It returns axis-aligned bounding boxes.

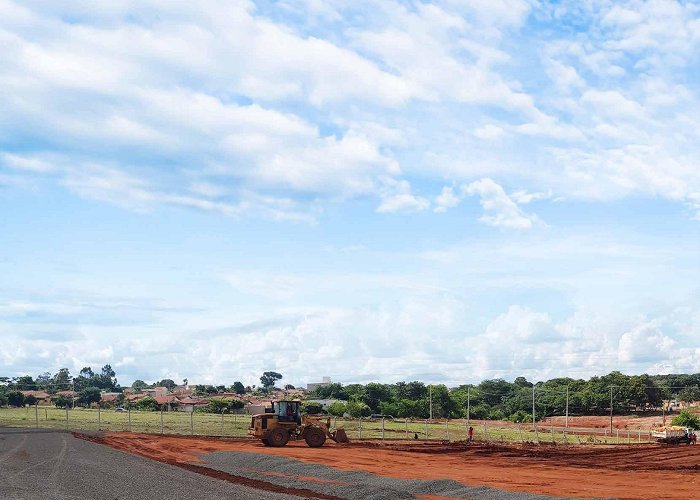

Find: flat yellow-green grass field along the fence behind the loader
[0,406,649,444]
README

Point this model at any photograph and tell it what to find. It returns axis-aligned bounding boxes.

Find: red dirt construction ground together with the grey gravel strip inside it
[81,433,700,500]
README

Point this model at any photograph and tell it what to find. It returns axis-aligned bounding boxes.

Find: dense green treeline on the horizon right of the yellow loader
[311,371,700,422]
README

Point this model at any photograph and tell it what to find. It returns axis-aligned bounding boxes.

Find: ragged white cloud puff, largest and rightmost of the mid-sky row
[462,178,539,229]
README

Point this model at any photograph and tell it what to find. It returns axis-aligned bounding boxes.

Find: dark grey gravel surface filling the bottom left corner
[0,428,297,500]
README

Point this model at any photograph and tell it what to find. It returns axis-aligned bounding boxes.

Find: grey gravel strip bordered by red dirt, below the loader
[200,452,612,500]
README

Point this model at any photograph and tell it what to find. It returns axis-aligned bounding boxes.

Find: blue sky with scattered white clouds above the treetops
[0,0,700,385]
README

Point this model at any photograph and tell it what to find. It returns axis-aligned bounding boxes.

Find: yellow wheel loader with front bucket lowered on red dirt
[248,401,348,448]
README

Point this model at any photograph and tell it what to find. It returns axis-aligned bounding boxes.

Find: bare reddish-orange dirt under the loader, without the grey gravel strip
[83,433,700,500]
